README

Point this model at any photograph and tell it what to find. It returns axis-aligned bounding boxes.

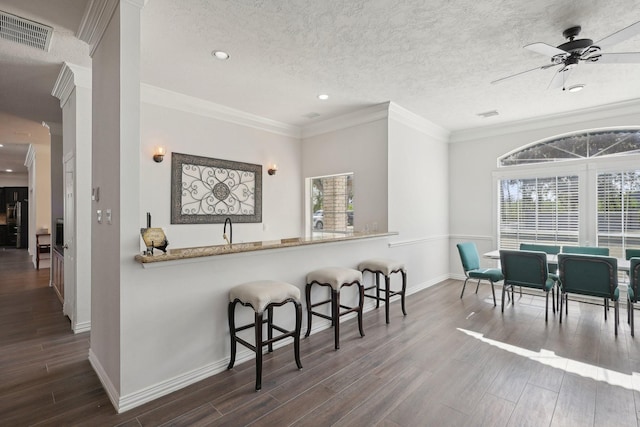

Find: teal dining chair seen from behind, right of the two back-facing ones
[558,253,620,335]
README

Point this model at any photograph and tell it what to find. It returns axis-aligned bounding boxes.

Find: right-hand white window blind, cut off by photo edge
[597,170,640,258]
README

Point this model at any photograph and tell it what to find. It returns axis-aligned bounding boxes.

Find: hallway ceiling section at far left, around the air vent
[0,0,91,174]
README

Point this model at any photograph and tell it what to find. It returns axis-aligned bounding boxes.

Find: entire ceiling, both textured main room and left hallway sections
[0,0,640,177]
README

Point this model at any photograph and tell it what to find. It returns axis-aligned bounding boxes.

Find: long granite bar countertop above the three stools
[135,232,397,264]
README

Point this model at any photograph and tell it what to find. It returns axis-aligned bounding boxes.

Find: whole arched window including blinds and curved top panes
[495,128,640,257]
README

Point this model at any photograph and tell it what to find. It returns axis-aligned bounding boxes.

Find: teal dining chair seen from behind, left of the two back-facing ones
[500,250,556,322]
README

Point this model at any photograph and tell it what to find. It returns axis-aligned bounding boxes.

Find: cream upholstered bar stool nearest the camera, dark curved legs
[227,280,302,391]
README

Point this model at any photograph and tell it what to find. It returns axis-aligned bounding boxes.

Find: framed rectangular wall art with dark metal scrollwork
[171,153,262,224]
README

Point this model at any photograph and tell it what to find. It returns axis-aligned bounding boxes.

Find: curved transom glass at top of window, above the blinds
[498,129,640,166]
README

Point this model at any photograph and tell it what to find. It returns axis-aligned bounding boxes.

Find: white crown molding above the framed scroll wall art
[140,83,300,138]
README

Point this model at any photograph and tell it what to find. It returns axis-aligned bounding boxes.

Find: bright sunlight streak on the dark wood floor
[457,328,640,391]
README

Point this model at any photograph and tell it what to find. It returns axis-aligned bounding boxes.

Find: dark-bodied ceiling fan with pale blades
[491,21,640,90]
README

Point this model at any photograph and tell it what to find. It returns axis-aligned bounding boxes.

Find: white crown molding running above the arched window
[449,99,640,143]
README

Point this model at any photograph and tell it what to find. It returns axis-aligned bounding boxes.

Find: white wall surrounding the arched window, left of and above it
[449,106,640,277]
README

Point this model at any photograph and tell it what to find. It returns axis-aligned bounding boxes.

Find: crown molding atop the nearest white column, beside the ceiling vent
[77,0,148,57]
